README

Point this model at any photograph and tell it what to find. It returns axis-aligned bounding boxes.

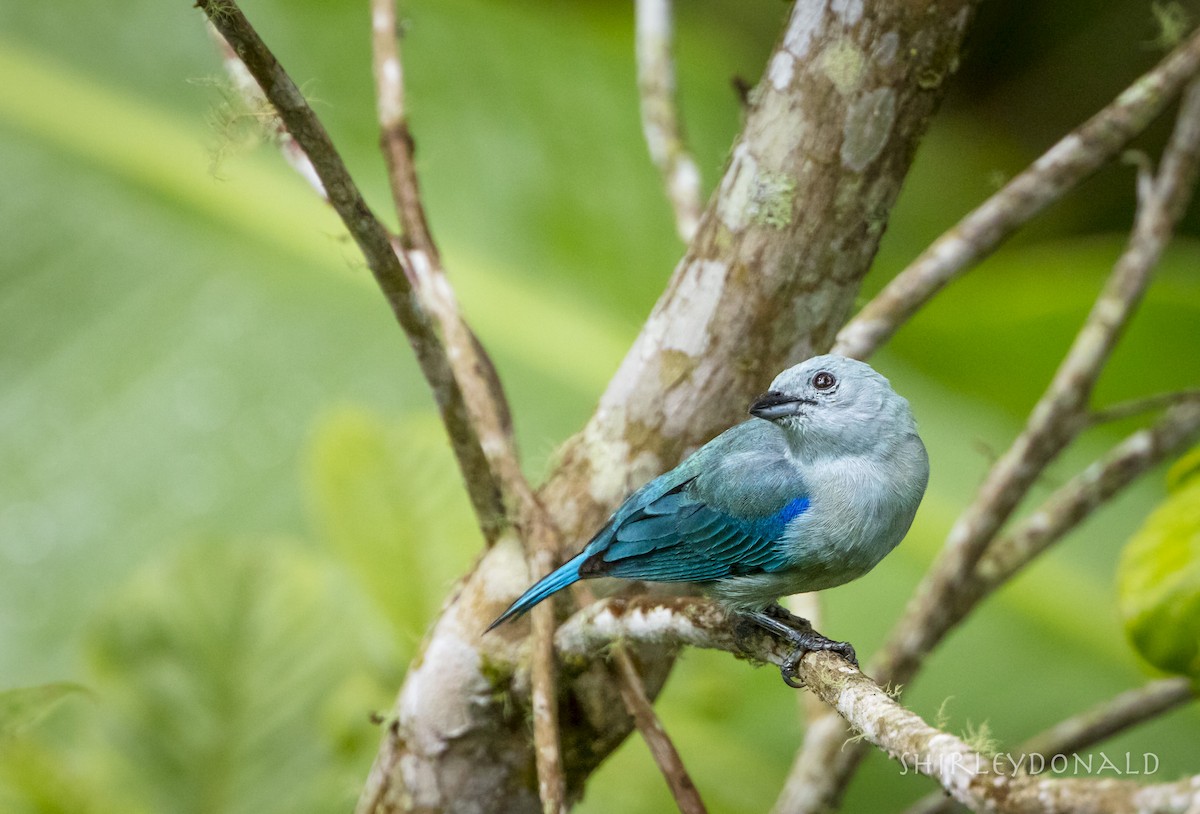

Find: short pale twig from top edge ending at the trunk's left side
[636,0,701,243]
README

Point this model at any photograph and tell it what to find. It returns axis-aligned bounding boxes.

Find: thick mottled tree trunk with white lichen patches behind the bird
[359,0,973,813]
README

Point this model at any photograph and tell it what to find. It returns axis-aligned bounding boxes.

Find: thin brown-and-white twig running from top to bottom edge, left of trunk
[371,0,566,814]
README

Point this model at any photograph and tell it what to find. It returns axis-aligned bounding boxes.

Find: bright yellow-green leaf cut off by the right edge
[1117,449,1200,680]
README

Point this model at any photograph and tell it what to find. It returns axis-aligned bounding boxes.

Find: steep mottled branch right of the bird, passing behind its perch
[778,82,1200,812]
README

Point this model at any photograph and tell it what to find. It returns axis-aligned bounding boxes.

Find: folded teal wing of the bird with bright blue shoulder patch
[580,473,809,582]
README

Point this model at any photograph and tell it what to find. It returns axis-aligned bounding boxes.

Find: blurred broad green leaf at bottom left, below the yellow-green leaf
[88,540,397,814]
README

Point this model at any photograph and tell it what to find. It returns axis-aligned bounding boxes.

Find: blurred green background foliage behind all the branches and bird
[0,0,1200,813]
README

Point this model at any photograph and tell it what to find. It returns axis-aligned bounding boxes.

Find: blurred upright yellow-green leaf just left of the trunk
[308,407,482,644]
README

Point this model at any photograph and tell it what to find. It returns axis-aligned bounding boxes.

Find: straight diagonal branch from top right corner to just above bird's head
[834,31,1200,359]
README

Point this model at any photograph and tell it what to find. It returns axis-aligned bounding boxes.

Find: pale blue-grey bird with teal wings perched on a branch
[488,354,929,687]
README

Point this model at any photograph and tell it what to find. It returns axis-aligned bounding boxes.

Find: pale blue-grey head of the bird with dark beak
[750,354,916,451]
